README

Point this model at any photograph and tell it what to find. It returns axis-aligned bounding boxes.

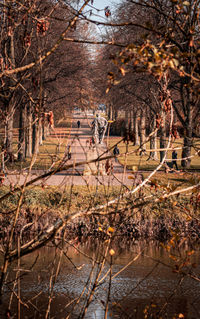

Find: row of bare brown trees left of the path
[0,0,92,165]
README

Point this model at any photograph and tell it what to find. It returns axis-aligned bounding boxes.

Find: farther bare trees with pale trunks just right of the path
[94,1,162,158]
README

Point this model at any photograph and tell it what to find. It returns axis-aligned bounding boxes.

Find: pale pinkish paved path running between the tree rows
[5,113,132,187]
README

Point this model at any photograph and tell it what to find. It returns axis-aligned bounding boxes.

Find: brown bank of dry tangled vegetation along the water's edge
[0,209,200,242]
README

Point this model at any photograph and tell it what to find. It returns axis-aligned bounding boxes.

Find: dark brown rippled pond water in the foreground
[0,239,200,319]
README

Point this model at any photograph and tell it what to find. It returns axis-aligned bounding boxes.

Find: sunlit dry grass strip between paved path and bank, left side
[0,185,122,214]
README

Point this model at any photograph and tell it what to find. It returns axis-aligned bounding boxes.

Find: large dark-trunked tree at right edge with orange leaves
[94,0,200,167]
